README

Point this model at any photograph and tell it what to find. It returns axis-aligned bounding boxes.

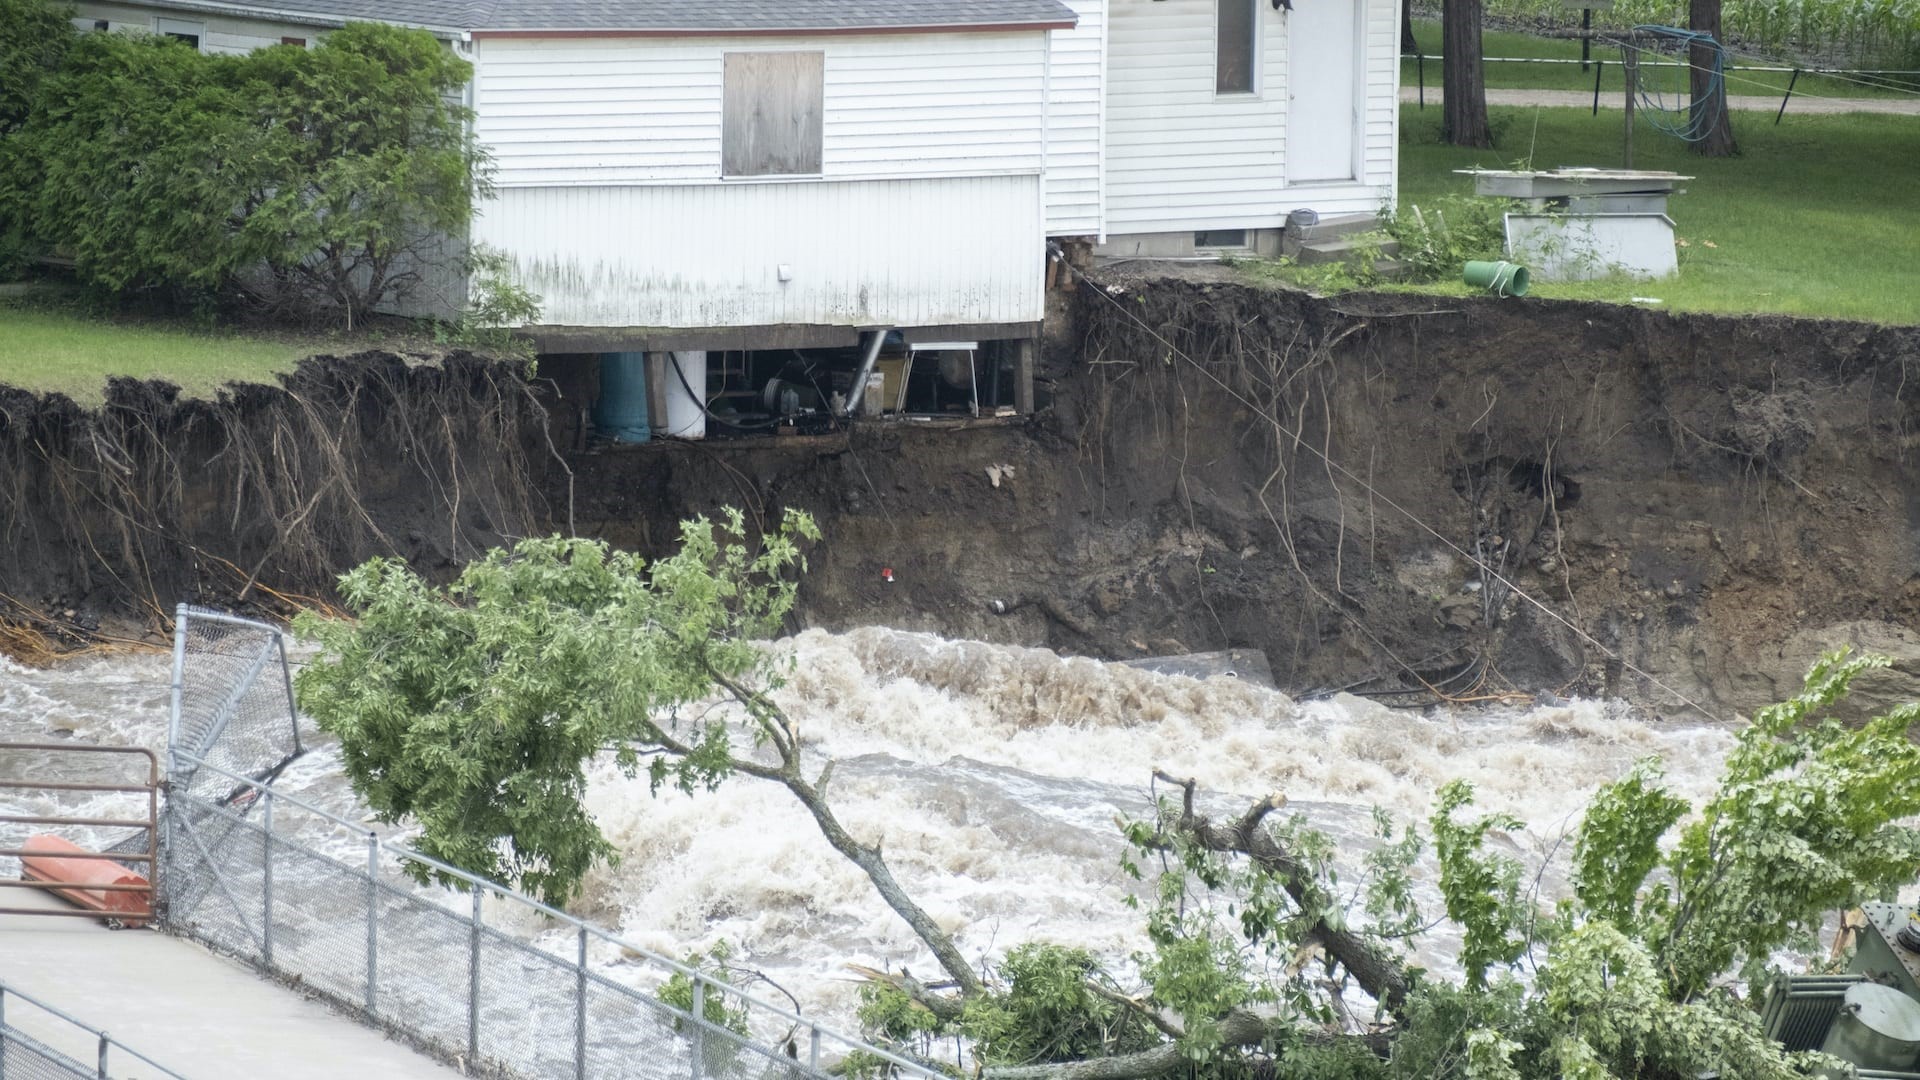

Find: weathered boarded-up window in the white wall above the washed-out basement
[720,52,826,177]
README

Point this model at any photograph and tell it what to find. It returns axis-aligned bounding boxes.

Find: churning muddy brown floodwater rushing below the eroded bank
[0,628,1732,1026]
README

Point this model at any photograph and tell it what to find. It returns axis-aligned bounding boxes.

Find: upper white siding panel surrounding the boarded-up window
[476,33,1046,186]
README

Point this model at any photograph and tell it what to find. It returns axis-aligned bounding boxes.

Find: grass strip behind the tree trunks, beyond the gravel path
[1400,19,1914,99]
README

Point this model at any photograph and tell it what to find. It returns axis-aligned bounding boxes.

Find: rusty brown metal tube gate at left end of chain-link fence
[0,742,159,924]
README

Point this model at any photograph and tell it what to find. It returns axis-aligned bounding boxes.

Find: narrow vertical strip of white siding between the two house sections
[1046,0,1106,236]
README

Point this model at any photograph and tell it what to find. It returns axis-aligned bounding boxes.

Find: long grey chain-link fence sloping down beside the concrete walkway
[163,749,937,1080]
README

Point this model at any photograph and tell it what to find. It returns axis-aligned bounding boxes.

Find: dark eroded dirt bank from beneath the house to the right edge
[549,281,1920,711]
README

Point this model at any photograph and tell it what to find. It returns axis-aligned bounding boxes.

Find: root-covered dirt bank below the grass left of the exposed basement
[0,354,545,634]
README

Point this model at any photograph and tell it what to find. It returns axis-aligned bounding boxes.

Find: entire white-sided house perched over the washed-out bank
[60,0,1400,424]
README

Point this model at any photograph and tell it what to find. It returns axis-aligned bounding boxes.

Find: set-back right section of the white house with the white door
[1046,0,1400,256]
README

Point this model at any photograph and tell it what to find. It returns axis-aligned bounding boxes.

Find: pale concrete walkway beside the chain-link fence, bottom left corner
[0,890,459,1080]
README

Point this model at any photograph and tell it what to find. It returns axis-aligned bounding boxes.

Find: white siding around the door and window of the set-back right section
[1106,0,1400,234]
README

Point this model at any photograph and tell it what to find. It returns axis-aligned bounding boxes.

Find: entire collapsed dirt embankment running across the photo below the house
[11,279,1920,709]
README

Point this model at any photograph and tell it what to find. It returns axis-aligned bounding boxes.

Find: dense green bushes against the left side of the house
[0,16,487,317]
